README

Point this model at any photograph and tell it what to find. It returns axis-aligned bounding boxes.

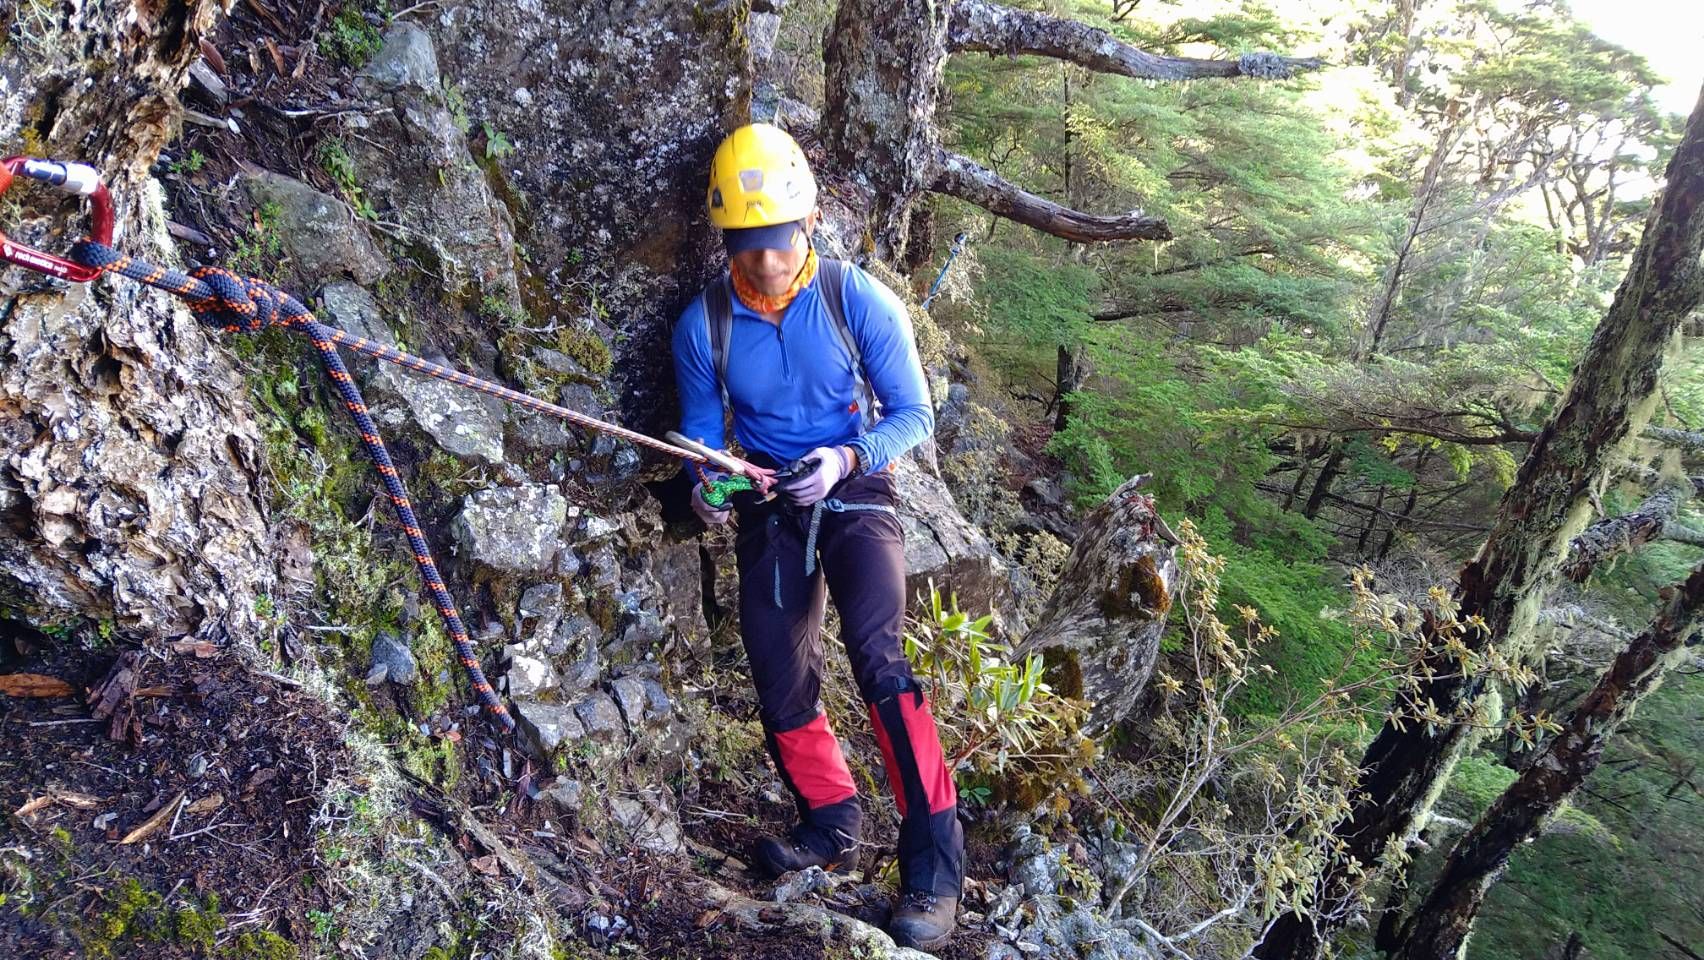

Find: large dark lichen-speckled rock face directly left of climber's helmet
[428,0,750,436]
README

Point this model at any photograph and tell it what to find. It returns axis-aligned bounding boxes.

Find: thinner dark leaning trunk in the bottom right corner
[1390,564,1704,960]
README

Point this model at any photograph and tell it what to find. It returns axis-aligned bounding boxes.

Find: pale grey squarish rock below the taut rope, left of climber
[455,484,567,573]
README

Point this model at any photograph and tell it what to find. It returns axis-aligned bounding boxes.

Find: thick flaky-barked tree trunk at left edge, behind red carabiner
[0,0,273,639]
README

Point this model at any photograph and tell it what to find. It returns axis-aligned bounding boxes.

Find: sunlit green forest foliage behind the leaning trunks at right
[872,0,1704,960]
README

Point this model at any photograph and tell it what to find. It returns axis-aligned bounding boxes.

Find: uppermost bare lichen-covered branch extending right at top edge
[947,0,1324,80]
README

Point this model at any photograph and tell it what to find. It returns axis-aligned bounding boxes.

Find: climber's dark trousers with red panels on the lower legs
[734,455,964,897]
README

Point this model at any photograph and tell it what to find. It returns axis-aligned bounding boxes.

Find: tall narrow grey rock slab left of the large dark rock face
[346,20,520,300]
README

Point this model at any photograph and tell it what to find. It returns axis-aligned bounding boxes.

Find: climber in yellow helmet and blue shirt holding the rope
[673,123,964,948]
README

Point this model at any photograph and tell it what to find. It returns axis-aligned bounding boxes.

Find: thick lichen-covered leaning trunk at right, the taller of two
[1256,80,1704,960]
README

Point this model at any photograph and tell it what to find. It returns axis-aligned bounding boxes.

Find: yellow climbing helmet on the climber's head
[705,123,816,230]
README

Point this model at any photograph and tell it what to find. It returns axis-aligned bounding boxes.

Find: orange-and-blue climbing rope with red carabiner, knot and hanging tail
[0,157,772,730]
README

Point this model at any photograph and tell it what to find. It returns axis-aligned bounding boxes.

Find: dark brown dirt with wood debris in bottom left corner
[0,627,349,957]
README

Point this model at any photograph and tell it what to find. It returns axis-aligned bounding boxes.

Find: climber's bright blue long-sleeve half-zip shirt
[675,266,935,472]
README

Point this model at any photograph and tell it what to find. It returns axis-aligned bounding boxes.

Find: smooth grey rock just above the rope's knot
[242,171,390,285]
